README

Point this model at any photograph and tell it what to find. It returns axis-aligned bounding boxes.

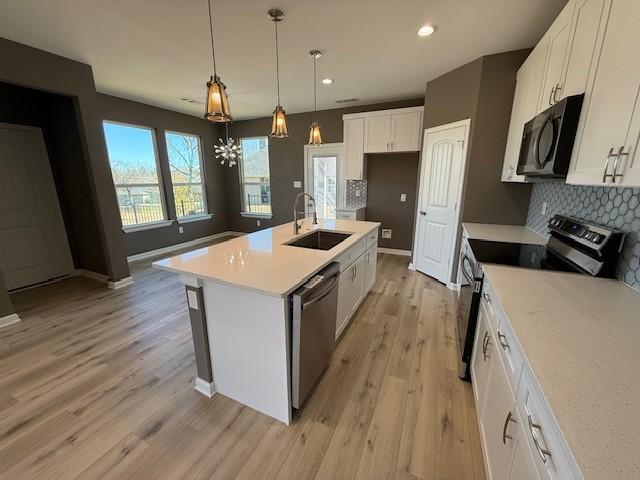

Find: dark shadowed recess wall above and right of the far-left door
[0,83,106,273]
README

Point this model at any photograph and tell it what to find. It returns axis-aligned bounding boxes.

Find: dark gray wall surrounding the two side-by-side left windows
[98,94,227,255]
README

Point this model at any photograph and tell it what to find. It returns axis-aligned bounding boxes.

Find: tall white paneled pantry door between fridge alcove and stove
[414,120,469,283]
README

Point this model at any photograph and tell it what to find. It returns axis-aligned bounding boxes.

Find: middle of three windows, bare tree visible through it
[165,132,207,218]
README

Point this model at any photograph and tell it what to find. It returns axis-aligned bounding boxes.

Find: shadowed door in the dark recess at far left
[0,124,74,290]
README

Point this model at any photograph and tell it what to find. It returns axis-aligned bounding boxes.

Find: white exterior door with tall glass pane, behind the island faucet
[304,144,344,219]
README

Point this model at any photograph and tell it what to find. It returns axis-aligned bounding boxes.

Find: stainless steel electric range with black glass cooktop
[457,215,624,380]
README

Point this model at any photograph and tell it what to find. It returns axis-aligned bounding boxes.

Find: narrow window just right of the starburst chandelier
[239,137,271,215]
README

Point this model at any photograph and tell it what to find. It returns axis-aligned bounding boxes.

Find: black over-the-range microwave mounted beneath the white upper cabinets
[517,94,584,178]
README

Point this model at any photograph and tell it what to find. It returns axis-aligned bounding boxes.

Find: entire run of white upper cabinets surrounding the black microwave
[502,0,640,186]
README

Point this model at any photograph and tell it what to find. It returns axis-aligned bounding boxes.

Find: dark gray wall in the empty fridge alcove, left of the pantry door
[367,152,420,250]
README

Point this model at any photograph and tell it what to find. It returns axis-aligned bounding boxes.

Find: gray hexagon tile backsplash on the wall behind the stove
[527,183,640,290]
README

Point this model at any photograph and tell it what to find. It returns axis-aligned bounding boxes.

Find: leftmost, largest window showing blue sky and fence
[103,122,167,227]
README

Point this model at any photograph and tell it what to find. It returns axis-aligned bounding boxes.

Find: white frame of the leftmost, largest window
[102,118,173,232]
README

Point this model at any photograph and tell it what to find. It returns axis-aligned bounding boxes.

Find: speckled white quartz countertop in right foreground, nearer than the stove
[483,265,640,479]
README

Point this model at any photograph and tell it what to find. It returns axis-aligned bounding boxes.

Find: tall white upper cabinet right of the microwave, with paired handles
[567,0,640,186]
